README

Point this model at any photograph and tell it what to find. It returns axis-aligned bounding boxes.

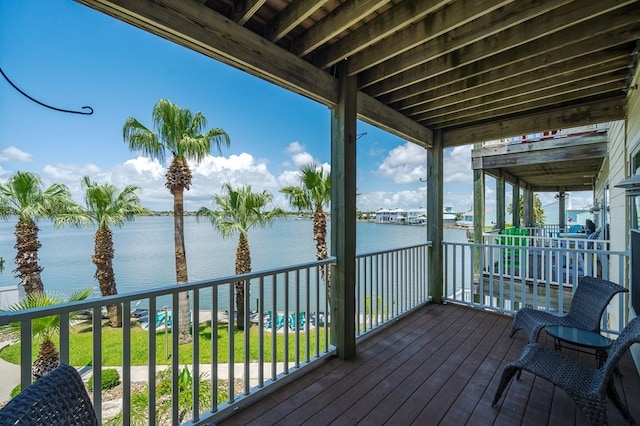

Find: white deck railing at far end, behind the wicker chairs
[443,234,629,333]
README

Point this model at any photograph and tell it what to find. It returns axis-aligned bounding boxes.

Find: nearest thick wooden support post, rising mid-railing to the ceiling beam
[331,61,358,359]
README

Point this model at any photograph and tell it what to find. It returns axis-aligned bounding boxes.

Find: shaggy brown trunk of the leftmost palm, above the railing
[14,219,44,295]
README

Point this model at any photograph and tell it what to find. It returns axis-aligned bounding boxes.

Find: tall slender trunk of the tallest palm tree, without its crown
[172,187,191,344]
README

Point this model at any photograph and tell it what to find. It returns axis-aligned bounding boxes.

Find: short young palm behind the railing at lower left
[1,287,93,380]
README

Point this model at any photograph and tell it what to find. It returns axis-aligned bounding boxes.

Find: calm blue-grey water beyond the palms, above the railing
[0,216,466,302]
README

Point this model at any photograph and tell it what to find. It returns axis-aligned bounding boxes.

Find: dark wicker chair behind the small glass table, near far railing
[509,277,628,343]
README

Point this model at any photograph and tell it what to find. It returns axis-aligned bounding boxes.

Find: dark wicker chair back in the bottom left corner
[0,364,98,426]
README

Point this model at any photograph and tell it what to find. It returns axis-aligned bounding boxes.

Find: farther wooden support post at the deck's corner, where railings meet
[427,131,444,303]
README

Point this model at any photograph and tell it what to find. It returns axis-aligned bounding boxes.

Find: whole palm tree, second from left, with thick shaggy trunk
[55,176,148,327]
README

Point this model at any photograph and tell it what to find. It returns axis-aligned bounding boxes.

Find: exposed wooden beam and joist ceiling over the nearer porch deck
[77,0,640,150]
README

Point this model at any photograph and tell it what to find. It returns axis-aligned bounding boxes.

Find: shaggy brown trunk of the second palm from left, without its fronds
[91,228,122,327]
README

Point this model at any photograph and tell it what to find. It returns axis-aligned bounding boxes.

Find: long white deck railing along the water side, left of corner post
[0,245,436,424]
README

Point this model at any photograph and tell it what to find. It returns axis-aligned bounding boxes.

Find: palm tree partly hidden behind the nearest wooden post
[280,163,331,288]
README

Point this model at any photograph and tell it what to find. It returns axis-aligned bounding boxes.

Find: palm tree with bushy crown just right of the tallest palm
[197,183,286,330]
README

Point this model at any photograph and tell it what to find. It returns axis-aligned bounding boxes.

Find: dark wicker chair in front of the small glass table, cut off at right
[492,318,640,425]
